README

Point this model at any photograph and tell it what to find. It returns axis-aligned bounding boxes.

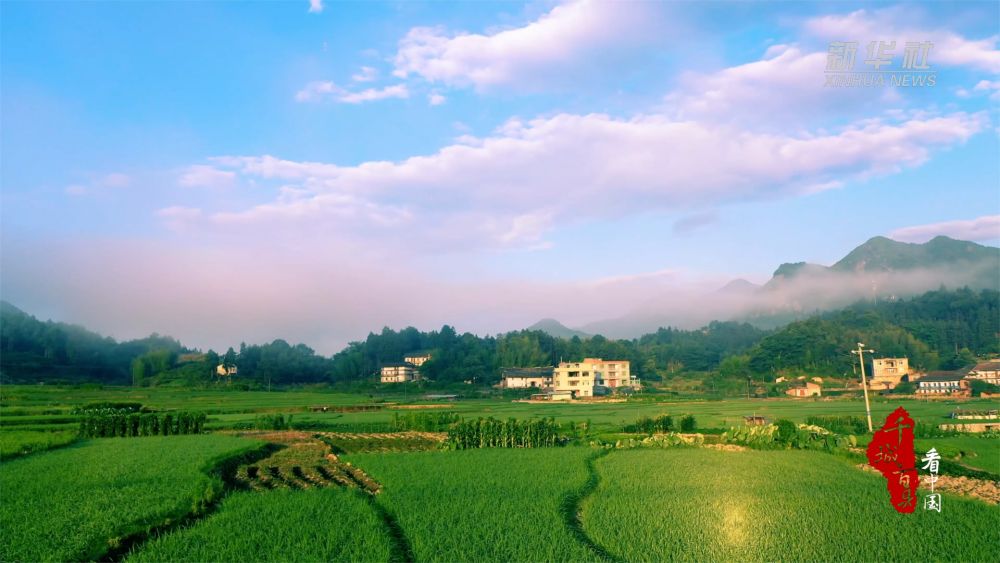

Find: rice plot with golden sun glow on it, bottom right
[583,449,1000,561]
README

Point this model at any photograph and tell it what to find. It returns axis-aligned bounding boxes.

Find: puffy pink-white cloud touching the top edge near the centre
[394,0,664,89]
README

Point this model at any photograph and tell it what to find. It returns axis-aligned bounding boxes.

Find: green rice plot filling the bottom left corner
[0,436,257,561]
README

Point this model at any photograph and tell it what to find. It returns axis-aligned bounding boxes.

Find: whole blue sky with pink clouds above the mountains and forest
[0,0,1000,354]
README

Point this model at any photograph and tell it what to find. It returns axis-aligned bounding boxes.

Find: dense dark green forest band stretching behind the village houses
[0,289,1000,388]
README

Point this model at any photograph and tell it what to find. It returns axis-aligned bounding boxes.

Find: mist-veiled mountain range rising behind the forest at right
[580,236,1000,338]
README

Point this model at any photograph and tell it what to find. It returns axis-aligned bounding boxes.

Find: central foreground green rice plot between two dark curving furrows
[348,448,595,561]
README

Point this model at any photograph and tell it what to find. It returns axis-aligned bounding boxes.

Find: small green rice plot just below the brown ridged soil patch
[132,488,392,563]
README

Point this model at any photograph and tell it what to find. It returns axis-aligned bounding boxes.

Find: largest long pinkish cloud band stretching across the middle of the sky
[188,112,987,251]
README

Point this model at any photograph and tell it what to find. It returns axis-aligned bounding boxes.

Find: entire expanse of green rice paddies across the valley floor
[0,387,1000,561]
